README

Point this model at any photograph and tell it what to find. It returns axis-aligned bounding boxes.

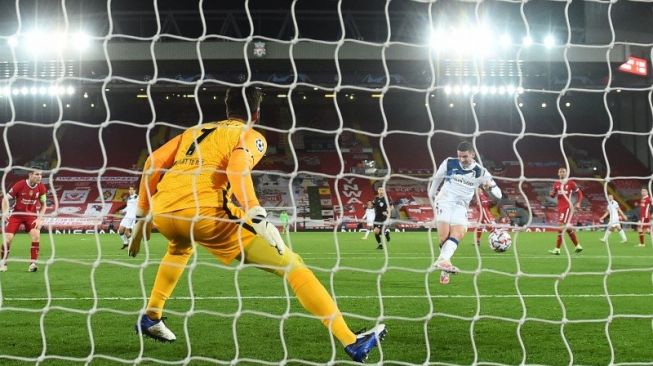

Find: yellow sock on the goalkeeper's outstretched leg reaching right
[288,267,356,346]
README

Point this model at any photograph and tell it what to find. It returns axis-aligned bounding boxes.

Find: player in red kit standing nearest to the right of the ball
[549,167,583,255]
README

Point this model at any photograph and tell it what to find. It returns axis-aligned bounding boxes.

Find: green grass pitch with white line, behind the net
[0,232,653,365]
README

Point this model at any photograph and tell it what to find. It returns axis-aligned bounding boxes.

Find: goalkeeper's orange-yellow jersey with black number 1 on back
[138,119,267,214]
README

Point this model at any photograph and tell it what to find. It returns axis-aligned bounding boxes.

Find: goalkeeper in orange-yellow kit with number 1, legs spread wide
[129,87,386,362]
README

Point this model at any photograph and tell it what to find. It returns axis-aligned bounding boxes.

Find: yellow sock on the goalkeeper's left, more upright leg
[147,248,193,320]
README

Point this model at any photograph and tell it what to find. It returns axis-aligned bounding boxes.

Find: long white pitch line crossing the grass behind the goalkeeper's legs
[3,293,653,301]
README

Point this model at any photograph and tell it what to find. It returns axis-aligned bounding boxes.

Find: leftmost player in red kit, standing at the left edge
[0,169,47,272]
